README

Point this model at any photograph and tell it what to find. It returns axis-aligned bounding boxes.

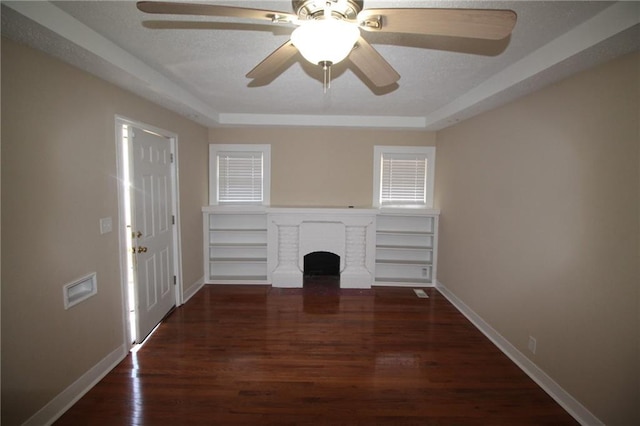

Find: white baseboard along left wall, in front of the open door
[22,345,128,426]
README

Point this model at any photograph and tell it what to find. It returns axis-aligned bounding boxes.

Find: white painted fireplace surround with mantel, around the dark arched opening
[267,208,377,288]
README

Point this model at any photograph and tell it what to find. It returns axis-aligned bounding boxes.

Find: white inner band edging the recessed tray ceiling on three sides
[2,1,640,130]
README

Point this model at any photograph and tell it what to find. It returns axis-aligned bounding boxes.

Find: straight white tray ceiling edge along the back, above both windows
[219,113,425,129]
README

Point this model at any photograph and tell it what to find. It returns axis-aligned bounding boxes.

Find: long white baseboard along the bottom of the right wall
[436,281,604,426]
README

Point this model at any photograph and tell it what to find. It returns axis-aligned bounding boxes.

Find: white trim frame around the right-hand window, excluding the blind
[372,145,436,209]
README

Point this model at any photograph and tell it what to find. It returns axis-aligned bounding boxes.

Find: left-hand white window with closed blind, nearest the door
[209,144,271,205]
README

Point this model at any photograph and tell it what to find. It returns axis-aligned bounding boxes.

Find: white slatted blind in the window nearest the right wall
[380,153,428,205]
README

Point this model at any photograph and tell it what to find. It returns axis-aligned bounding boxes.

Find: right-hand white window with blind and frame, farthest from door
[373,146,436,208]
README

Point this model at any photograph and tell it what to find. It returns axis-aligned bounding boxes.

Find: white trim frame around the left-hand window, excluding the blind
[209,144,271,206]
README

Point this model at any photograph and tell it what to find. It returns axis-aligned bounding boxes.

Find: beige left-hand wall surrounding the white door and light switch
[2,38,208,425]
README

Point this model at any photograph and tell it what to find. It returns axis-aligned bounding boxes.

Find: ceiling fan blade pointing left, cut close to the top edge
[136,1,298,22]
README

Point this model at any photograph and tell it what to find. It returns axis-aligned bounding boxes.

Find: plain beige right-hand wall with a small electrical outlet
[436,53,640,425]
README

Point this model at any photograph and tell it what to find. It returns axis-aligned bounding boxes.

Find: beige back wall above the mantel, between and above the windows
[209,128,435,207]
